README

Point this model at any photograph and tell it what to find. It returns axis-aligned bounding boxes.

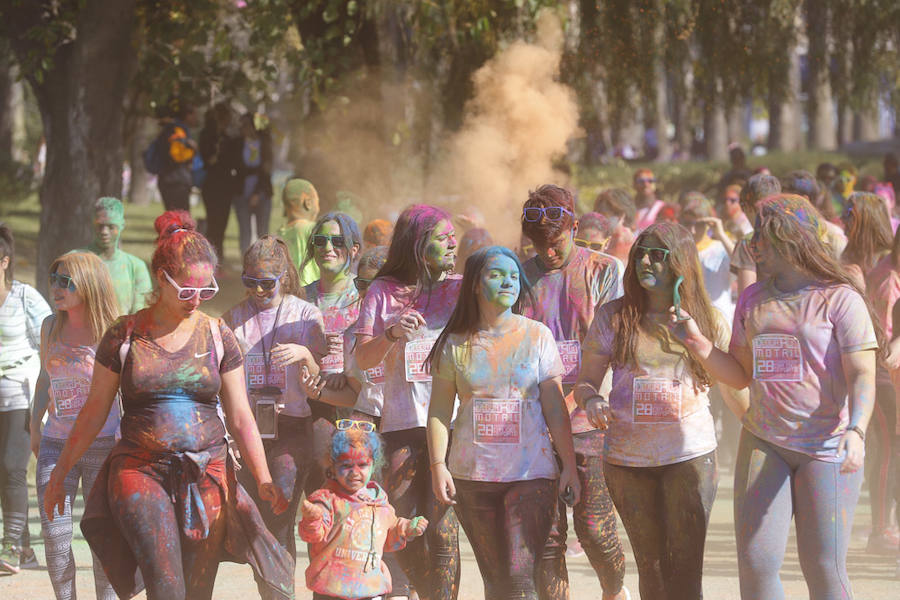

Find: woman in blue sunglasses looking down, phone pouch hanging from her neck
[222,235,327,580]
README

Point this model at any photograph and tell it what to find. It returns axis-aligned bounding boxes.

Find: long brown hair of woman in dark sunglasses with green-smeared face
[612,222,722,388]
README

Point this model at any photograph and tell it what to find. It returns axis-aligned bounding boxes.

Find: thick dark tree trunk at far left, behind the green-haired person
[7,0,136,292]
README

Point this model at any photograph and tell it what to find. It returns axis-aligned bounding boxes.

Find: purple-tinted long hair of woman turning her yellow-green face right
[375,204,450,302]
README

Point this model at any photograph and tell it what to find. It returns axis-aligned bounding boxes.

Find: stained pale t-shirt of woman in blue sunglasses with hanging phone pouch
[222,295,328,417]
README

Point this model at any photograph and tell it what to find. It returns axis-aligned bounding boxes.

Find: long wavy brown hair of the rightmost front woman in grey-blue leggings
[754,194,885,357]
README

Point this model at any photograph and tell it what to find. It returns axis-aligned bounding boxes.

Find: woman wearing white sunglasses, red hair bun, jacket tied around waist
[44,211,293,600]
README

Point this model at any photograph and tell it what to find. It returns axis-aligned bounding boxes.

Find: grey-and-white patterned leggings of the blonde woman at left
[36,437,116,600]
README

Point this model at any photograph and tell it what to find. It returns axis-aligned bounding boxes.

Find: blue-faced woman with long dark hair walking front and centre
[428,246,581,600]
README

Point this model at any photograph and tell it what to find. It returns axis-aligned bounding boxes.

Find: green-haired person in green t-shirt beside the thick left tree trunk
[85,197,153,315]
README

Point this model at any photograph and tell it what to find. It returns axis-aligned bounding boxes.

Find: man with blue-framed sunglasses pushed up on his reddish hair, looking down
[522,185,627,600]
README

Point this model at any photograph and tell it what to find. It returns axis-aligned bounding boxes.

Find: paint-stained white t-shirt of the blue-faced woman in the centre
[434,315,563,482]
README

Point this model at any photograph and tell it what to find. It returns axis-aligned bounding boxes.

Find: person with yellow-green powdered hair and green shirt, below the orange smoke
[278,178,319,286]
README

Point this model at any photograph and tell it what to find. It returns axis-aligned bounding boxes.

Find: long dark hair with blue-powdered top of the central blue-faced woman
[426,246,534,369]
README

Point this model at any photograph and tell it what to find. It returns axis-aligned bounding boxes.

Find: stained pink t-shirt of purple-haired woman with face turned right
[356,274,462,432]
